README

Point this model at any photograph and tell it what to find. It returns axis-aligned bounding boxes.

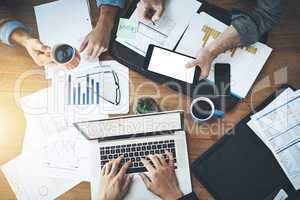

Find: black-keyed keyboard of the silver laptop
[100,140,177,173]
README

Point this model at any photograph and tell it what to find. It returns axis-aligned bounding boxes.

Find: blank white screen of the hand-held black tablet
[148,47,195,84]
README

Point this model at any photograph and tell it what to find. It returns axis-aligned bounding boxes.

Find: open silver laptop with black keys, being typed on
[74,111,192,200]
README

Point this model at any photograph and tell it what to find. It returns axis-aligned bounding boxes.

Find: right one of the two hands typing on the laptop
[139,152,183,200]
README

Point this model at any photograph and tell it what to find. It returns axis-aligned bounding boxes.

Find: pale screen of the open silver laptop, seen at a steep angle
[74,111,183,139]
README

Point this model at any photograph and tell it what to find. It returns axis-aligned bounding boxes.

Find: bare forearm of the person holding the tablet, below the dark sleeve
[206,26,241,57]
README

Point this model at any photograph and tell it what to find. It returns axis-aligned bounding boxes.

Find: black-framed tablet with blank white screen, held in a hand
[144,45,201,84]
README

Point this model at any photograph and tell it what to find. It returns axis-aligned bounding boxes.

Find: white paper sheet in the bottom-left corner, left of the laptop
[1,155,81,200]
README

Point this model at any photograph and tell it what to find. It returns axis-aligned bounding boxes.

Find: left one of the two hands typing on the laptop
[99,156,133,200]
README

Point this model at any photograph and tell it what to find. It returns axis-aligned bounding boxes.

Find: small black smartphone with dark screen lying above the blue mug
[215,63,230,95]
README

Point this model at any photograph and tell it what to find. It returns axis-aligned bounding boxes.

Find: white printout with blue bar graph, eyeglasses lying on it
[65,61,129,114]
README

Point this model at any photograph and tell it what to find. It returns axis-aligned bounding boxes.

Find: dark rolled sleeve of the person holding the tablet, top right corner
[231,0,287,46]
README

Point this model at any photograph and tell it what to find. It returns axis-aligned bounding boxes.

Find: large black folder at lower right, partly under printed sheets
[191,85,300,200]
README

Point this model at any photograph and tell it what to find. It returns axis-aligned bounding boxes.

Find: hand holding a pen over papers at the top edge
[137,0,165,22]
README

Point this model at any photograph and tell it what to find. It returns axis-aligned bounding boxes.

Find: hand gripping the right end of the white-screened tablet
[186,47,217,79]
